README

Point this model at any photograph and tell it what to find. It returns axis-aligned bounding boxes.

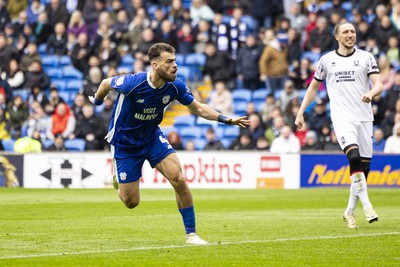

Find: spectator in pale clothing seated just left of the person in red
[26,101,49,142]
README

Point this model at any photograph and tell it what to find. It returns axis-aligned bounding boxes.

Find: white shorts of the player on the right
[332,121,373,158]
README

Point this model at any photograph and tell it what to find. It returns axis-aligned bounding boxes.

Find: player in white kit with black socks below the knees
[295,22,383,229]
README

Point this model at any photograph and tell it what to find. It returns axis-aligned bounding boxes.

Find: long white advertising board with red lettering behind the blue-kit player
[24,151,300,189]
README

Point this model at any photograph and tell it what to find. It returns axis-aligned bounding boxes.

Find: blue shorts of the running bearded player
[111,132,175,183]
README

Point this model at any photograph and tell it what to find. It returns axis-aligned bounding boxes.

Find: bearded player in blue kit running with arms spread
[89,43,249,245]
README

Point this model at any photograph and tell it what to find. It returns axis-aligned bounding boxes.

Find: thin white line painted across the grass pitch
[0,232,400,260]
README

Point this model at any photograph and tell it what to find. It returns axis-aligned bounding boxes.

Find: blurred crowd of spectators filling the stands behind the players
[0,0,400,153]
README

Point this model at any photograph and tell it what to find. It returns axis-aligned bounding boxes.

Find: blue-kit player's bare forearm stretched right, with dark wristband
[188,99,249,128]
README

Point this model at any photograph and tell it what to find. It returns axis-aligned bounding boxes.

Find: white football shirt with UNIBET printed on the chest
[314,49,379,121]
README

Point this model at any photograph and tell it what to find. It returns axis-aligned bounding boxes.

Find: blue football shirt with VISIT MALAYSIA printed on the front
[106,72,194,149]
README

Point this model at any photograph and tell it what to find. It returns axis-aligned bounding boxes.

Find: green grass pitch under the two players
[0,188,400,266]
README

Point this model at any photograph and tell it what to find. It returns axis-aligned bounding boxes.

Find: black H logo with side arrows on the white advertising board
[40,158,92,188]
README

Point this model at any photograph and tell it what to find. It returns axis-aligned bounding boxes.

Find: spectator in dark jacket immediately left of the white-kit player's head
[306,17,335,55]
